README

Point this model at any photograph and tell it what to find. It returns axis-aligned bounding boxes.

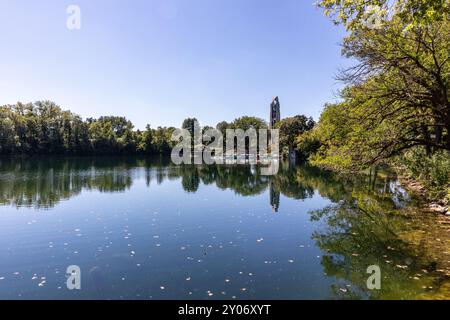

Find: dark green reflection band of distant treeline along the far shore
[0,157,412,207]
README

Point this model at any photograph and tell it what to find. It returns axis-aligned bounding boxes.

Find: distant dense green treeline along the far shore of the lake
[0,101,314,155]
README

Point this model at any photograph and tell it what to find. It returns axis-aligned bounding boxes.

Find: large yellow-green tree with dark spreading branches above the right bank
[314,1,450,170]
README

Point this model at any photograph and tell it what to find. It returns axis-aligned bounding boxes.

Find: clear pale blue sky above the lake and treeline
[0,0,349,128]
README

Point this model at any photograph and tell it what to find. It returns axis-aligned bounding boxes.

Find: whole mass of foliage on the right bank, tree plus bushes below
[296,0,450,199]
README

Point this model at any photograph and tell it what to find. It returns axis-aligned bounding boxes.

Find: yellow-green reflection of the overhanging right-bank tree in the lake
[310,172,449,299]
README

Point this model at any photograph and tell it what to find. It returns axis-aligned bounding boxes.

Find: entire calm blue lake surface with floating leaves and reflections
[0,158,450,299]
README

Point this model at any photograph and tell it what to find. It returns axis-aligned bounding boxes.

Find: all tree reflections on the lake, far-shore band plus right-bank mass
[0,158,450,299]
